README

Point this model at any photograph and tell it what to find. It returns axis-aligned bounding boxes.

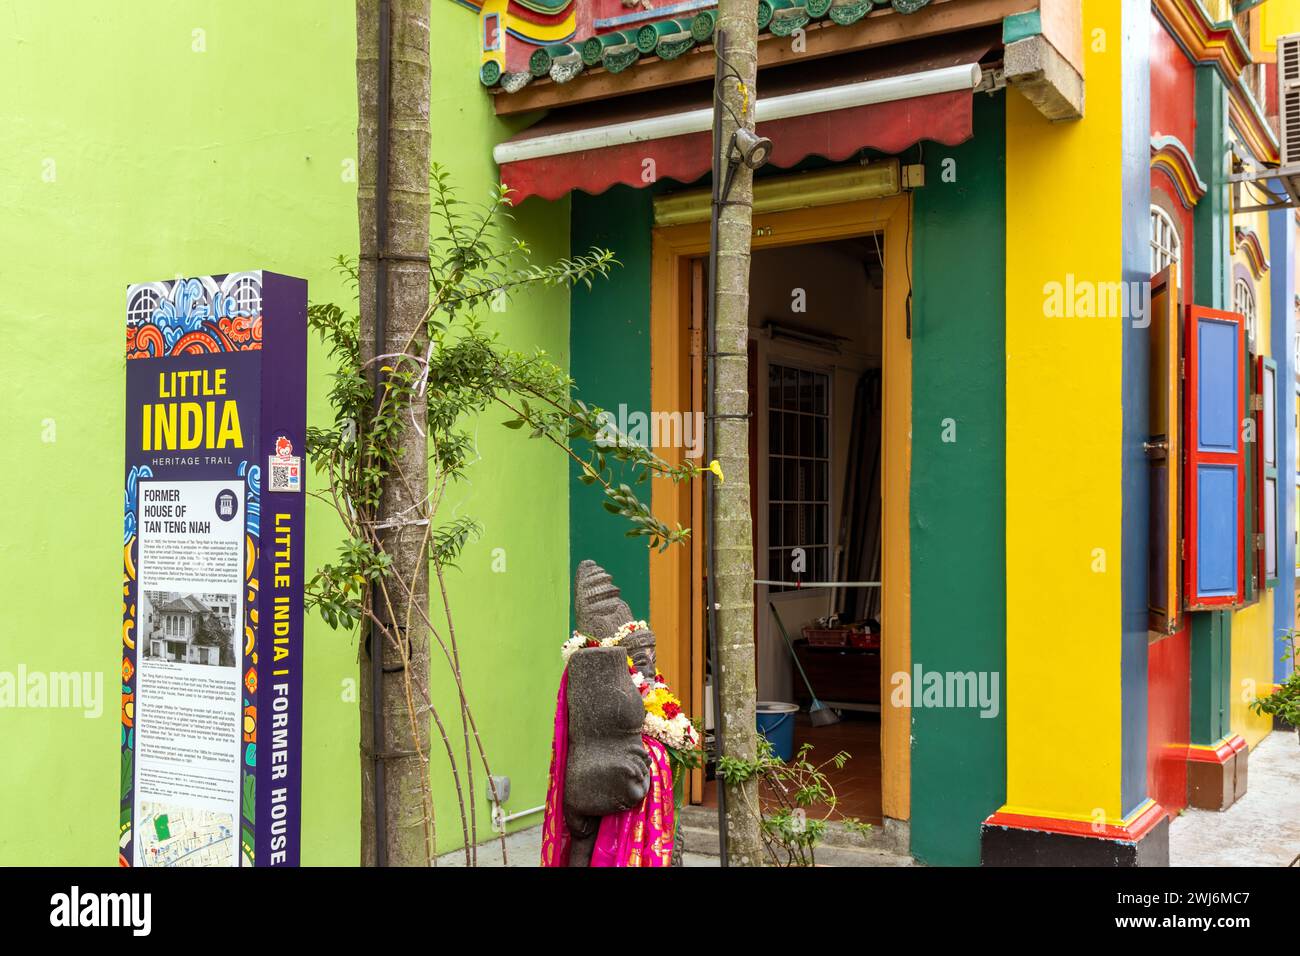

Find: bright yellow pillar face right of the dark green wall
[1004,0,1123,822]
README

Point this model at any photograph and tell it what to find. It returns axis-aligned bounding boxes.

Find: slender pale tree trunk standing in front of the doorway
[711,0,763,866]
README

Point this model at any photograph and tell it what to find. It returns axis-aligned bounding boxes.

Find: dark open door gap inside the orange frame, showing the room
[705,234,884,825]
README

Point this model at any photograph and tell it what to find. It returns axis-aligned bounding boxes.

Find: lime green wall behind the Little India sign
[0,0,569,865]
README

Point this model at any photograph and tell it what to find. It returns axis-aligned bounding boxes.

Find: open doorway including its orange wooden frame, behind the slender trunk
[650,196,911,823]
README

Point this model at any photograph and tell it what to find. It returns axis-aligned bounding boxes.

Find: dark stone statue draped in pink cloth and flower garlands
[542,561,673,866]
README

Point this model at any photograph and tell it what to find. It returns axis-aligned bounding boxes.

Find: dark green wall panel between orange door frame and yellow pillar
[911,96,1006,865]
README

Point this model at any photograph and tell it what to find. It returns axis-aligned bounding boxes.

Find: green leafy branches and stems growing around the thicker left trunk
[306,165,698,862]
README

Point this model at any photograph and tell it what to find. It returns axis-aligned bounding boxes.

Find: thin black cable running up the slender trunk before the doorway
[705,30,731,866]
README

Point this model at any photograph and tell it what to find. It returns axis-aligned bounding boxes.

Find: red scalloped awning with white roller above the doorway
[495,40,991,202]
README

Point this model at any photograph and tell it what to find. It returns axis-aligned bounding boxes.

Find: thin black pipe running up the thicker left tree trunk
[371,0,393,866]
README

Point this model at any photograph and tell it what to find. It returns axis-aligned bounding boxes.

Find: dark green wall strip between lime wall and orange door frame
[569,186,654,617]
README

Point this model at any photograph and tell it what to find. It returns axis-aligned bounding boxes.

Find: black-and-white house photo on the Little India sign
[140,591,239,667]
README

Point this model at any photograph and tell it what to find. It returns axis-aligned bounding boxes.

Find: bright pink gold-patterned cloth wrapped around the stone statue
[542,670,673,866]
